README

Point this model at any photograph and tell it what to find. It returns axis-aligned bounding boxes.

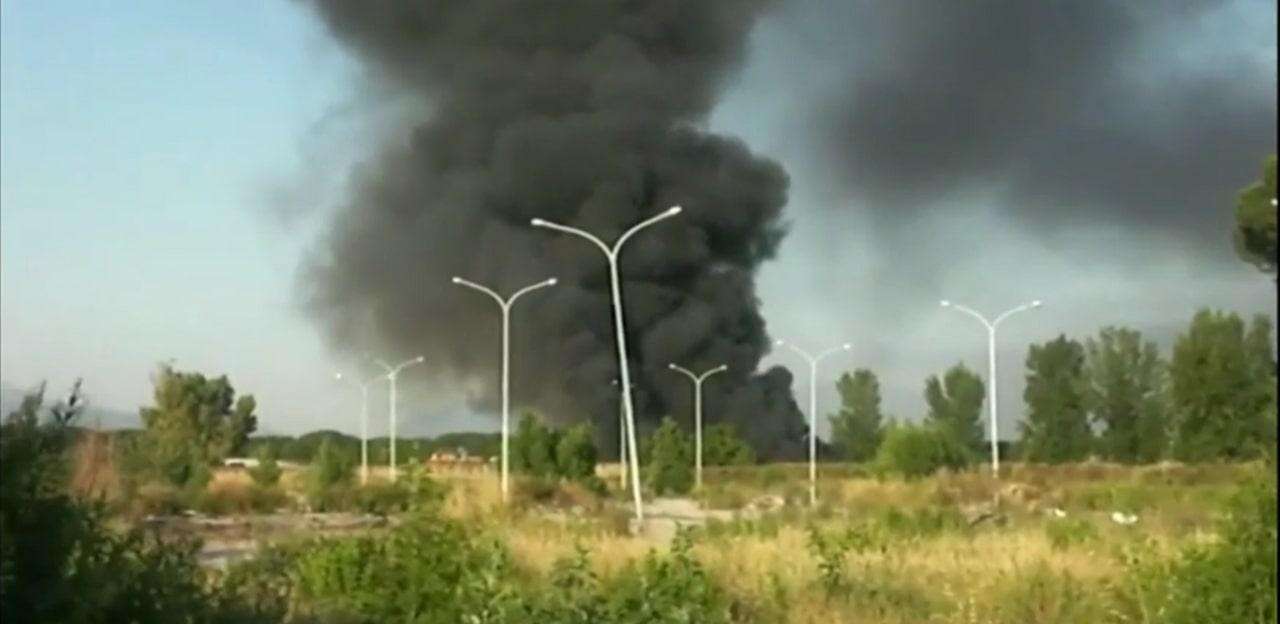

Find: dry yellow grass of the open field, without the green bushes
[93,442,1274,624]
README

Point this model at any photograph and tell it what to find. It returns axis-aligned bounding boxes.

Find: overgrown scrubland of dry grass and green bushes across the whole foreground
[0,378,1276,624]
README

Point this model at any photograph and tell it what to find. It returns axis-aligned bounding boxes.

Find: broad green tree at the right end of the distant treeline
[1170,309,1276,460]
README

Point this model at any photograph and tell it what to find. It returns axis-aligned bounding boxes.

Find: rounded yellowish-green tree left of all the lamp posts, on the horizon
[137,366,257,486]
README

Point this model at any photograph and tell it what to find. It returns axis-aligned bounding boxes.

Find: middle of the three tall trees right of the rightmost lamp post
[1084,327,1169,463]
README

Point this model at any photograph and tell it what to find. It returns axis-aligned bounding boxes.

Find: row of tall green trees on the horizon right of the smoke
[829,309,1276,465]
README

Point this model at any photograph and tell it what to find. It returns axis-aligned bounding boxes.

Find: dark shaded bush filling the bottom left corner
[0,384,267,624]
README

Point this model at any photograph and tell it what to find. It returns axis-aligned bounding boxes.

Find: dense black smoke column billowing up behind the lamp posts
[295,0,804,454]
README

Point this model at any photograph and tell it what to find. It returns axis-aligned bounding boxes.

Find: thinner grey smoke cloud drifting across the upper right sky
[817,0,1276,247]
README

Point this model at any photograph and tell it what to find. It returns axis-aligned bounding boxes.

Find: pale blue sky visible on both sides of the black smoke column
[0,0,1275,432]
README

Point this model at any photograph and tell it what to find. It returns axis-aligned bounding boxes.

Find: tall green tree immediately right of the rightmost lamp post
[1021,335,1093,464]
